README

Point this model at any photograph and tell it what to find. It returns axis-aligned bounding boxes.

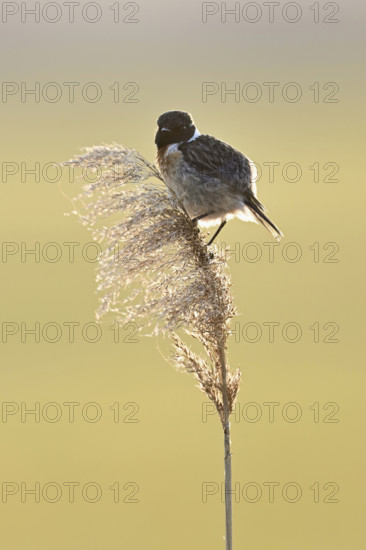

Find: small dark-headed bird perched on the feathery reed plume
[155,111,283,245]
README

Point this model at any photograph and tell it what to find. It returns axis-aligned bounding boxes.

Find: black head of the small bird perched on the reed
[155,111,196,149]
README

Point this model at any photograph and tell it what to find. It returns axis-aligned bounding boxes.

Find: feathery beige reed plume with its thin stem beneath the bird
[66,145,240,550]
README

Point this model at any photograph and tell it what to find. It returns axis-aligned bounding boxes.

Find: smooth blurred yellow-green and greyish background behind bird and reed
[0,0,366,550]
